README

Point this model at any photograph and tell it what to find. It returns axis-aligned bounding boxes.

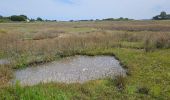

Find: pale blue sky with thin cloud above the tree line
[0,0,170,20]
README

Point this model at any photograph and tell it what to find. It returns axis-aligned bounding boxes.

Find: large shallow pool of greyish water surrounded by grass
[13,56,125,86]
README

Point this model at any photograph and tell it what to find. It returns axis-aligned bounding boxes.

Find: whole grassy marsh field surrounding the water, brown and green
[0,21,170,100]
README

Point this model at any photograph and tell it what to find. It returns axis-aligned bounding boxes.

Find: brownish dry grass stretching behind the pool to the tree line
[0,21,170,66]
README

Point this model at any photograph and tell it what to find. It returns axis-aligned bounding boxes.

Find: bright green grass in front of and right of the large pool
[0,48,170,100]
